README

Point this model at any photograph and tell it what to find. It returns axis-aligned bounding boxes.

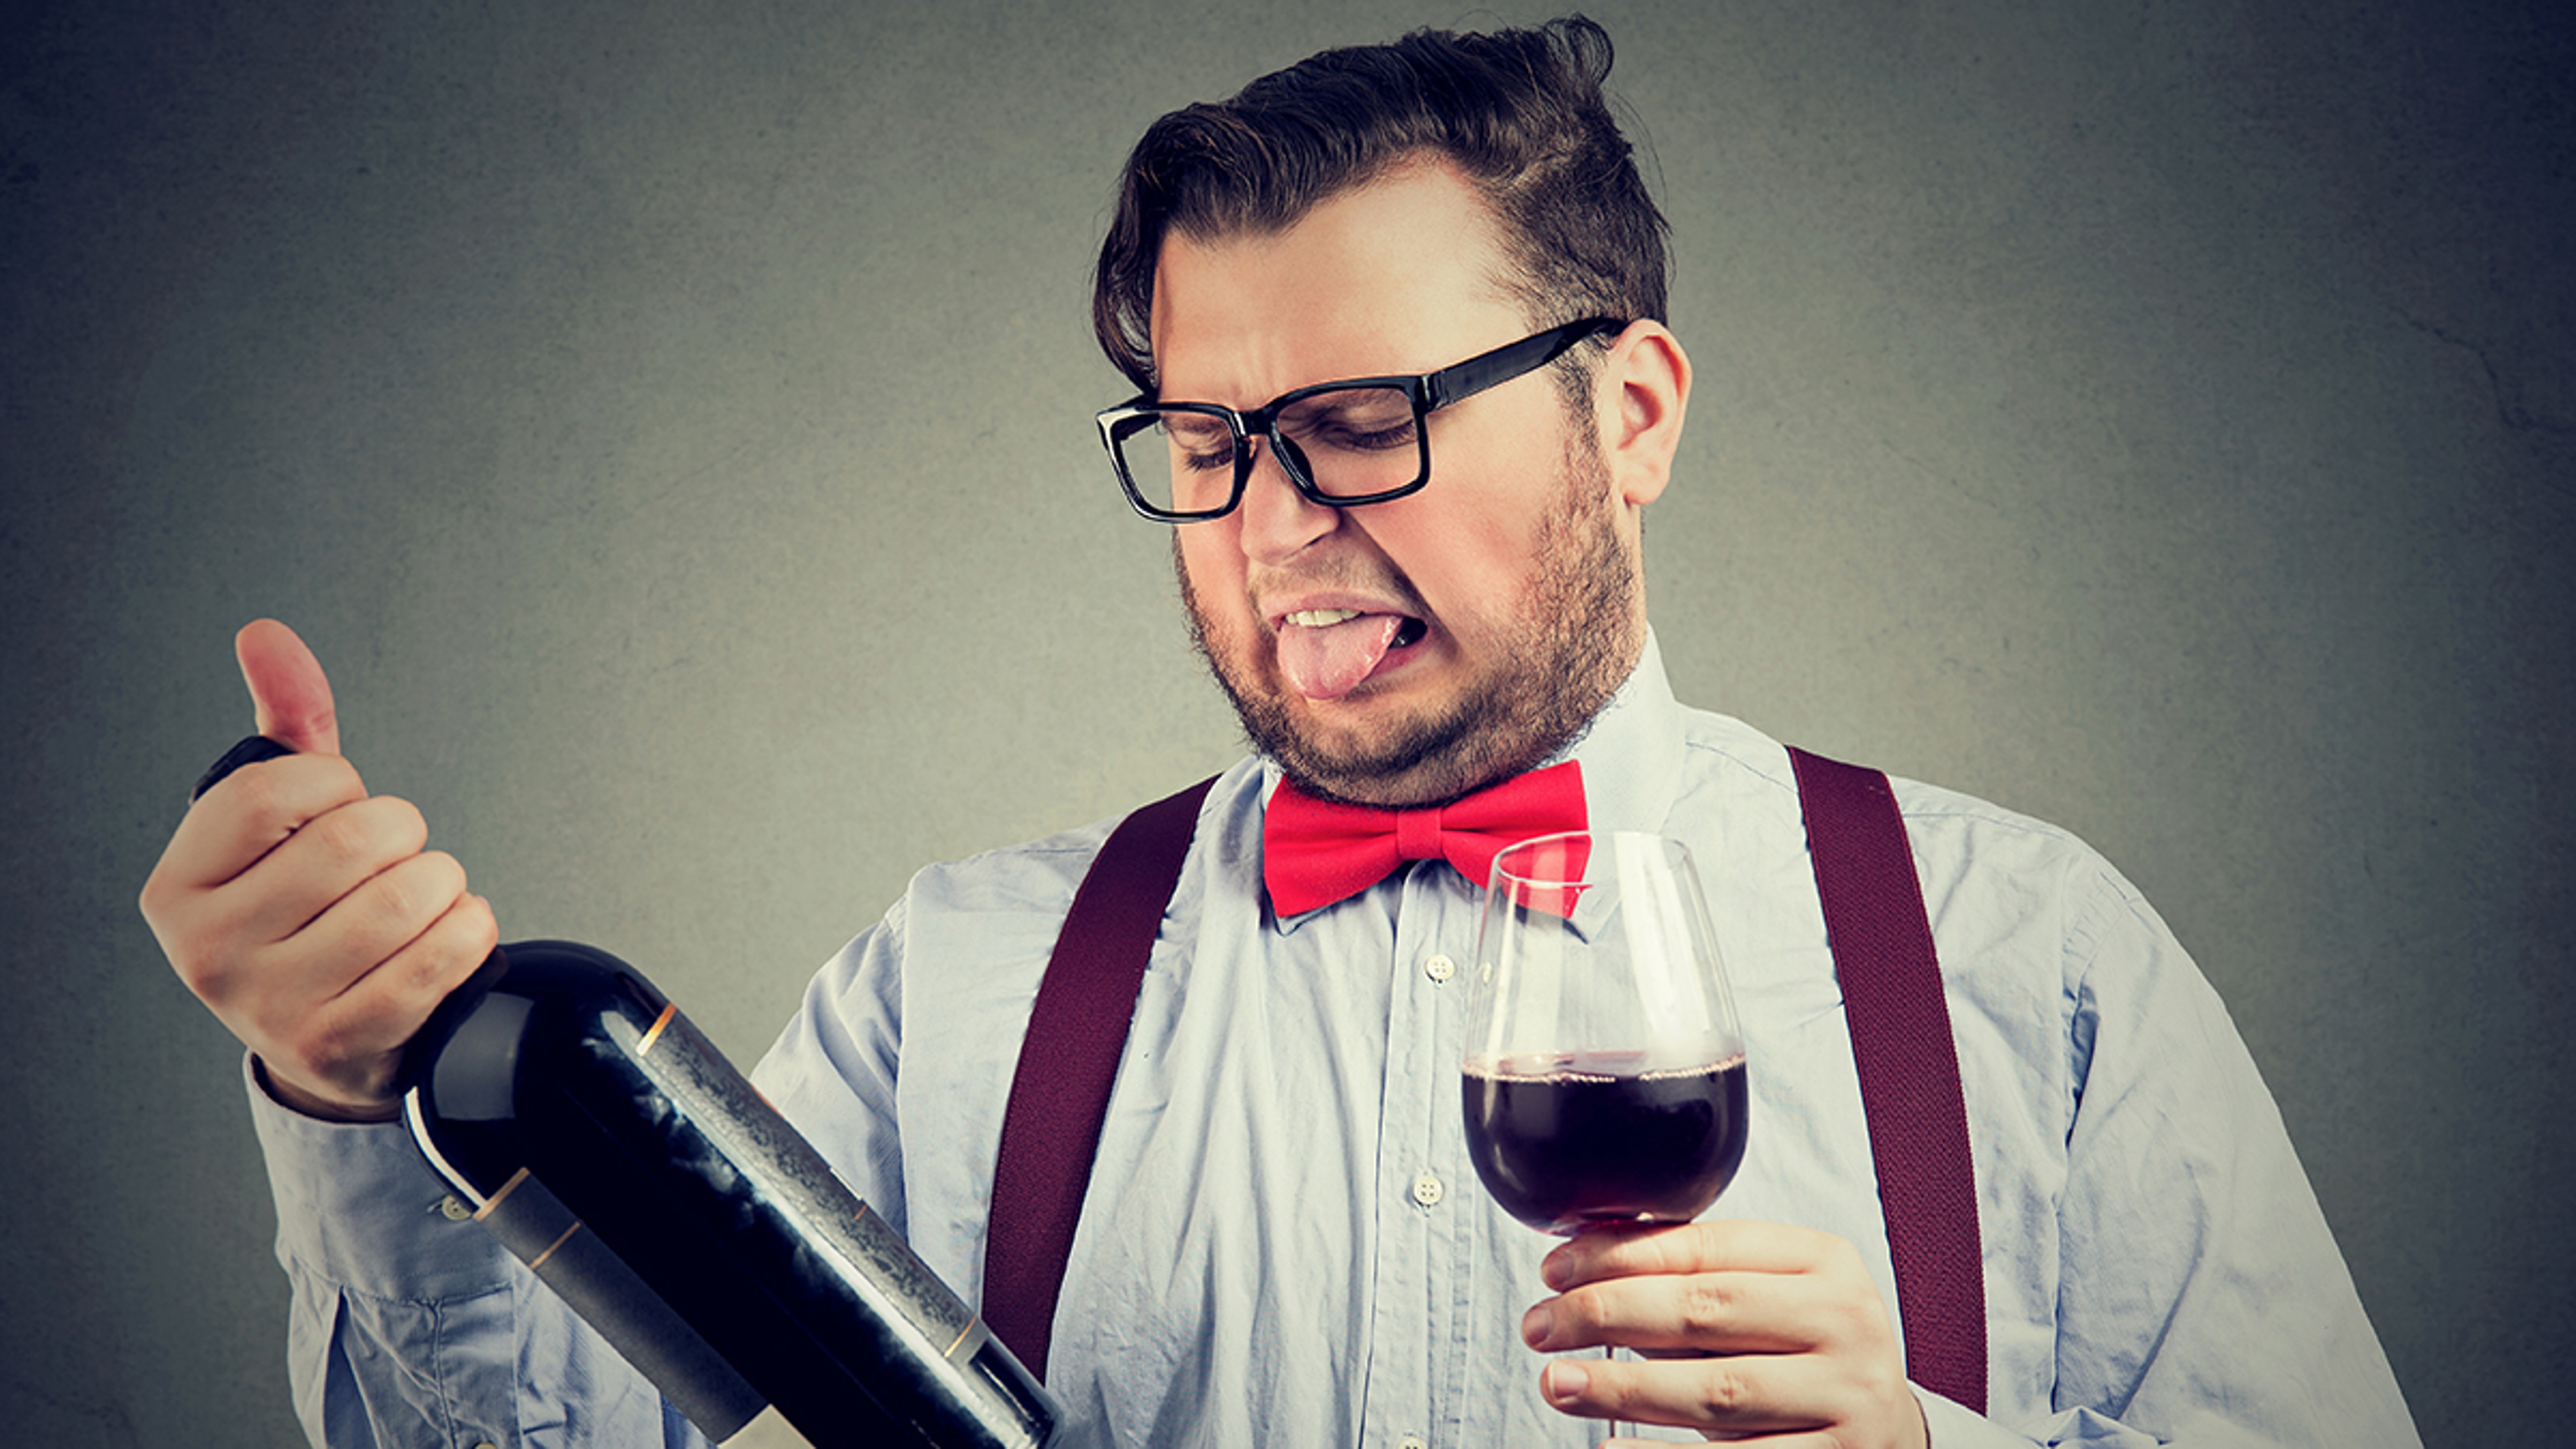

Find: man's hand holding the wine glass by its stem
[1520,1222,1927,1449]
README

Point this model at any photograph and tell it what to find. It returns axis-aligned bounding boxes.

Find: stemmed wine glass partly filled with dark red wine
[1463,833,1747,1423]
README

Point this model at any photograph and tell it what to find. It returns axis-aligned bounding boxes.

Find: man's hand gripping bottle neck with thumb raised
[142,619,500,1122]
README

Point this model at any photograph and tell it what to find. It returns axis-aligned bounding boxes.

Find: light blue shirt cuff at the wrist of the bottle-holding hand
[242,1052,513,1302]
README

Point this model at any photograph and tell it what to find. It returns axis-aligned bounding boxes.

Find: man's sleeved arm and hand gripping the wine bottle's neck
[142,621,700,1449]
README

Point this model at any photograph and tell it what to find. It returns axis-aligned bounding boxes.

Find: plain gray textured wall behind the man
[0,0,2576,1446]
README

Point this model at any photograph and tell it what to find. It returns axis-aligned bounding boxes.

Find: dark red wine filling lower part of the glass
[1463,1052,1747,1232]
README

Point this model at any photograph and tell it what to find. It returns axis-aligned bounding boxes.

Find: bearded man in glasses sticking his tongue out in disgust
[144,21,2414,1446]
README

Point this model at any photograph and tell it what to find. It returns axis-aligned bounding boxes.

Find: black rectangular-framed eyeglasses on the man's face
[1100,317,1625,523]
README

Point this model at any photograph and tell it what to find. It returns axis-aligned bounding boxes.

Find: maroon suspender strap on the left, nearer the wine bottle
[984,776,1216,1382]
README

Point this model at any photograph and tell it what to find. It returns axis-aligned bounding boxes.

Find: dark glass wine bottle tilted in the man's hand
[199,740,1056,1449]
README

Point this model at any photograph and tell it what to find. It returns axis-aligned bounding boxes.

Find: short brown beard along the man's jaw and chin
[1172,433,1644,807]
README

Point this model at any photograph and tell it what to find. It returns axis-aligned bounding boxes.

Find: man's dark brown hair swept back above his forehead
[1092,15,1664,392]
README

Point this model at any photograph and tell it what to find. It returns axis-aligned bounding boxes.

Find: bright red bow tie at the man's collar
[1263,761,1585,915]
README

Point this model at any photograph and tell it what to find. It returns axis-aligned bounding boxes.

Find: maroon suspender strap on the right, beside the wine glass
[1788,750,1986,1413]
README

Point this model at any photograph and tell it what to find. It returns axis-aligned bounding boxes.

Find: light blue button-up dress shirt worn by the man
[237,639,2416,1449]
